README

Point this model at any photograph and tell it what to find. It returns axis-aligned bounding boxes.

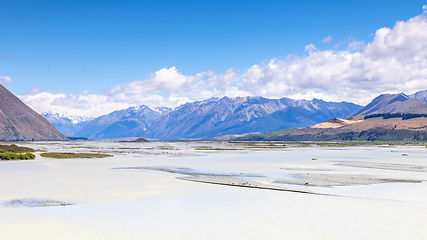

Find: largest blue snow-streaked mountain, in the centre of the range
[140,97,360,139]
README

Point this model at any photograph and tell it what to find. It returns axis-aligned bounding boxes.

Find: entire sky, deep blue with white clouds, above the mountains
[0,0,427,117]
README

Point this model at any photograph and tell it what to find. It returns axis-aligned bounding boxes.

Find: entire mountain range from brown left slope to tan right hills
[0,79,427,141]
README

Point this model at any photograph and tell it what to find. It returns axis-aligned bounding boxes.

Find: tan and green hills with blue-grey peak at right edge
[241,91,427,141]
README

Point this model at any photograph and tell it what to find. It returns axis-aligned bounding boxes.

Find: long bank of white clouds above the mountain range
[18,5,427,117]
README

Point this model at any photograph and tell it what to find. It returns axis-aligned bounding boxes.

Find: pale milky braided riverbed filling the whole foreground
[0,142,427,240]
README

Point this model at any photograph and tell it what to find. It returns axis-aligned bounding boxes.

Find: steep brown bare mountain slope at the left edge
[0,84,68,141]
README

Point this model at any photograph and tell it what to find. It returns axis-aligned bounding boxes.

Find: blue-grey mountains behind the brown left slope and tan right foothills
[36,88,427,140]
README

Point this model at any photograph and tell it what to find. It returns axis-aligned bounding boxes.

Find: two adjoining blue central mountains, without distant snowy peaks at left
[74,97,362,140]
